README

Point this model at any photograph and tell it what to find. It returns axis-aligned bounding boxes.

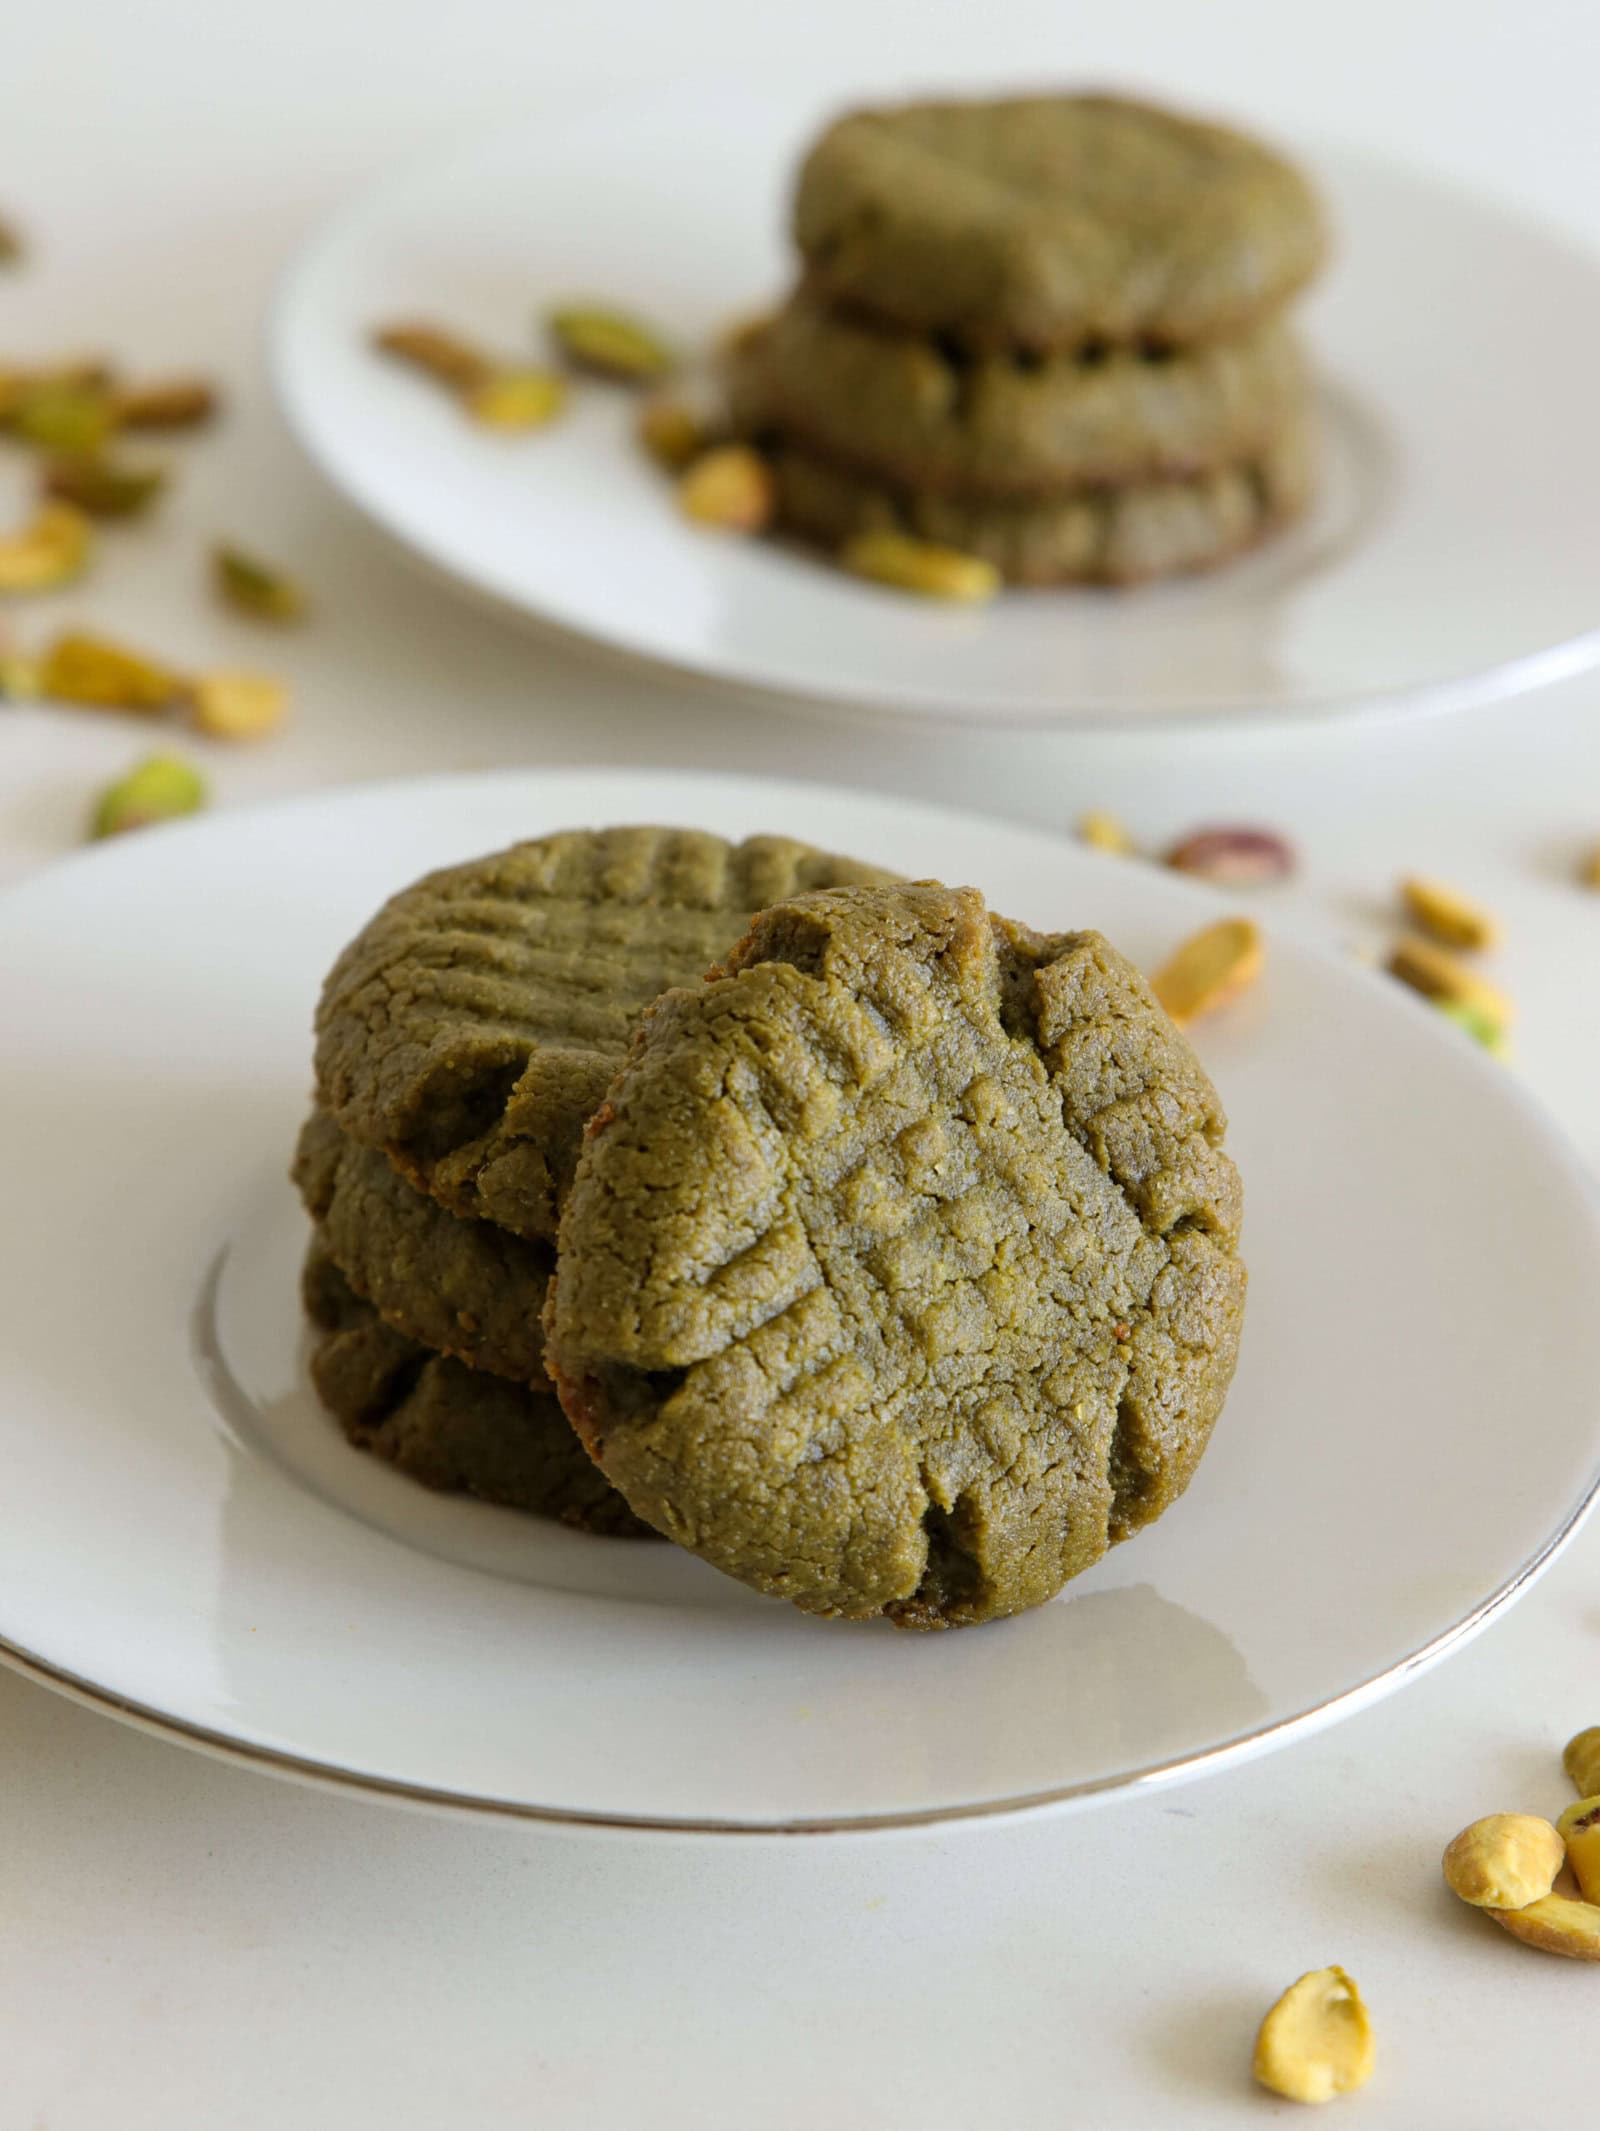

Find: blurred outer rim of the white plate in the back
[264,95,1600,737]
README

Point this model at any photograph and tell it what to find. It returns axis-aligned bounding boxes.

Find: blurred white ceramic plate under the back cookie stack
[273,92,1600,725]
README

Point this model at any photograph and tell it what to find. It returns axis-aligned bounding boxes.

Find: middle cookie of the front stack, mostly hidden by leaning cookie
[292,1110,554,1387]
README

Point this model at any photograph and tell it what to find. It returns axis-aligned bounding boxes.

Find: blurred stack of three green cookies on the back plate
[733,96,1325,584]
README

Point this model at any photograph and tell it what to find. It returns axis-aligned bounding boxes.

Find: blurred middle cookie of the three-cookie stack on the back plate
[733,294,1310,501]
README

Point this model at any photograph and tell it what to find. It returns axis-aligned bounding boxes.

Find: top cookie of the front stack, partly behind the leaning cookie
[315,829,903,1238]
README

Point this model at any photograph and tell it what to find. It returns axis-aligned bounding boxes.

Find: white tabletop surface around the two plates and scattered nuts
[0,0,1600,2131]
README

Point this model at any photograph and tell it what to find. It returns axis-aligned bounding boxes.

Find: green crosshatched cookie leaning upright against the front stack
[548,882,1244,1628]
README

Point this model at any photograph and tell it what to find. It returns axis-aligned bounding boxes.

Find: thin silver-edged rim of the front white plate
[0,763,1600,1839]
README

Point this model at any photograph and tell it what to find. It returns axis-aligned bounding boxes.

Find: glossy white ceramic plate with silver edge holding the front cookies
[0,771,1600,1831]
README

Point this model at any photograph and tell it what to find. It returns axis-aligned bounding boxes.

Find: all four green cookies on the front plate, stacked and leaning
[296,829,1244,1628]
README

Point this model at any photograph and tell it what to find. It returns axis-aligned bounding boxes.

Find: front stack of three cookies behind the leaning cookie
[294,829,903,1536]
